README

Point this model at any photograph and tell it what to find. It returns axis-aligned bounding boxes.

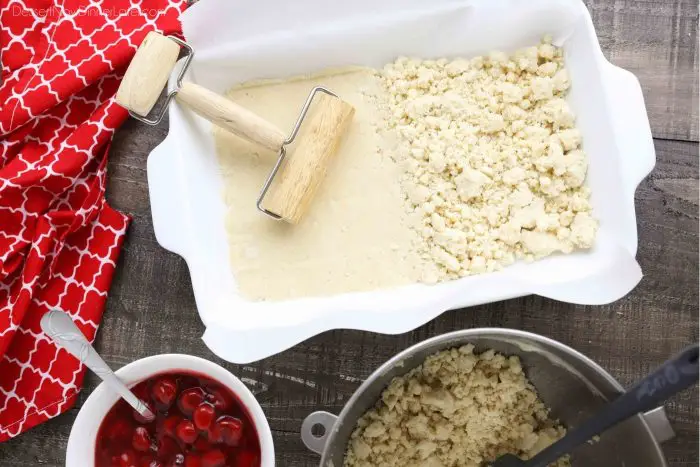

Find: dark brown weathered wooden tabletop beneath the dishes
[0,0,698,467]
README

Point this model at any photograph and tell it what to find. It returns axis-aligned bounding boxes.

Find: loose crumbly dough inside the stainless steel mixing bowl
[344,345,570,467]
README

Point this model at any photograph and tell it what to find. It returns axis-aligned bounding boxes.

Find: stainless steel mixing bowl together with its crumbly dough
[301,328,673,467]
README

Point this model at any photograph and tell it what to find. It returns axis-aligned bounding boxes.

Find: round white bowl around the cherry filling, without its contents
[66,354,275,467]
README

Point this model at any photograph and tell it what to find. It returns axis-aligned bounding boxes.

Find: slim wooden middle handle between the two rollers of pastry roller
[175,82,287,151]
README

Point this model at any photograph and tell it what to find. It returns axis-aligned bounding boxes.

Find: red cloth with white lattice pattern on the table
[0,0,185,442]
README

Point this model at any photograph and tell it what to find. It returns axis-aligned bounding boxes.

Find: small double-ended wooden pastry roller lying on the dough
[116,32,355,224]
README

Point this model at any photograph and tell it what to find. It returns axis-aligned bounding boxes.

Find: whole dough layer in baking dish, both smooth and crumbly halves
[215,38,598,300]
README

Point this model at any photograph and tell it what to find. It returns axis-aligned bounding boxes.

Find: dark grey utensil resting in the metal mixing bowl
[491,344,698,467]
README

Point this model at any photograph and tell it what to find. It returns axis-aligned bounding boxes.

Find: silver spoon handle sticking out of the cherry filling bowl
[41,309,155,421]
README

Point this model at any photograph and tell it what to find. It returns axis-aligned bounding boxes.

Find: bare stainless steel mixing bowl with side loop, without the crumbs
[301,328,673,467]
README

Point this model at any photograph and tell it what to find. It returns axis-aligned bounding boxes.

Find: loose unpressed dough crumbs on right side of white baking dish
[379,39,598,280]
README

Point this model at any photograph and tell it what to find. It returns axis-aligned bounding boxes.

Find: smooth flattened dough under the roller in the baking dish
[215,69,432,300]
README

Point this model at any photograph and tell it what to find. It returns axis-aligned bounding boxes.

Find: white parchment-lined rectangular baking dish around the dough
[148,0,655,363]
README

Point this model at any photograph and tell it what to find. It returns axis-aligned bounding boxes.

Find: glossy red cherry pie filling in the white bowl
[95,373,260,467]
